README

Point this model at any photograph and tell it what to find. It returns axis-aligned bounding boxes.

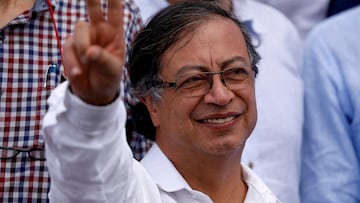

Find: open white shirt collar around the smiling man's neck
[141,144,280,203]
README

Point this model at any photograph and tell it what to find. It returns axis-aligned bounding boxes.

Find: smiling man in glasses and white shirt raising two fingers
[44,0,279,203]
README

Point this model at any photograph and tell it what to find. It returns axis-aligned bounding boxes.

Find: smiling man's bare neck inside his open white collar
[169,147,247,203]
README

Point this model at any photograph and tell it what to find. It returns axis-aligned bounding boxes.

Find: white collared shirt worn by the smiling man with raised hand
[44,82,280,203]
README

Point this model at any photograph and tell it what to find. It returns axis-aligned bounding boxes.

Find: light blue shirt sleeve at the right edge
[301,30,360,203]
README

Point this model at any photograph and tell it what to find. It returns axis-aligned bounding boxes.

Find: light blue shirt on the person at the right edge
[301,7,360,203]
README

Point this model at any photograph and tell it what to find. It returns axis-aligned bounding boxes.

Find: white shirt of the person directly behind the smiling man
[135,0,304,203]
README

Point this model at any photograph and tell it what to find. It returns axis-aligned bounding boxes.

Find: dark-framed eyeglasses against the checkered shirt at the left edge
[0,147,46,161]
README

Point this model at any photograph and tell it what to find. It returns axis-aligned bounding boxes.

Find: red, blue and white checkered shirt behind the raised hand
[0,0,141,202]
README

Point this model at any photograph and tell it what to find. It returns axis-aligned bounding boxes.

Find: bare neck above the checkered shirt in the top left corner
[0,0,35,28]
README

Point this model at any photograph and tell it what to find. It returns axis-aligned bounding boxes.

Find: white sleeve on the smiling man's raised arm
[43,82,161,203]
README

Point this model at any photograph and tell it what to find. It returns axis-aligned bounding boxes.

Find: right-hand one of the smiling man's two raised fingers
[108,0,124,29]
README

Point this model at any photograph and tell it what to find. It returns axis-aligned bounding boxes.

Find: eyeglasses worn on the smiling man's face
[146,66,257,97]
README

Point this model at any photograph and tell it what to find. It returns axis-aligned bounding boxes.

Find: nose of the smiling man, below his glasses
[204,75,235,106]
